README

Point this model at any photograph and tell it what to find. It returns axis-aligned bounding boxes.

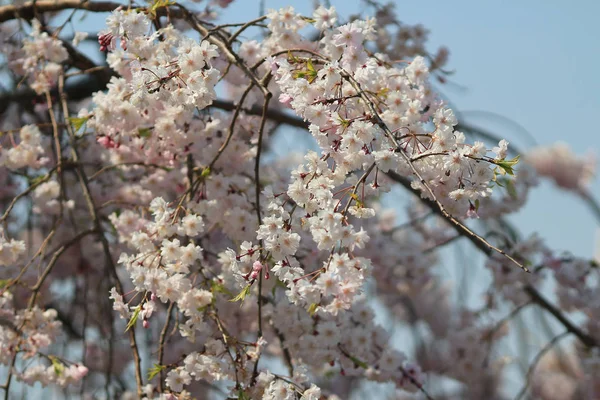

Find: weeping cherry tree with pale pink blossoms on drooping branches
[0,0,600,400]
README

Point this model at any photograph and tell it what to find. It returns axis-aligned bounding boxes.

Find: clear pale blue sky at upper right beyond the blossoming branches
[223,0,600,257]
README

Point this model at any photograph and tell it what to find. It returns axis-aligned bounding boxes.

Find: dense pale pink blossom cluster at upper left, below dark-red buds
[89,10,219,164]
